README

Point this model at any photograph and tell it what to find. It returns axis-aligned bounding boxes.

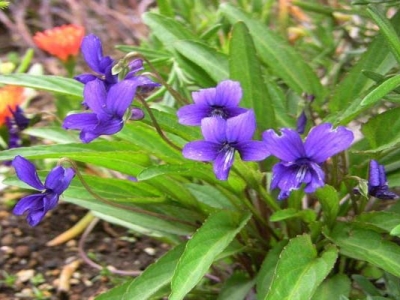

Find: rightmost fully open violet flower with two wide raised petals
[263,123,354,200]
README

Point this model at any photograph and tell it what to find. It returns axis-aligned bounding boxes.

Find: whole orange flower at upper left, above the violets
[33,24,85,61]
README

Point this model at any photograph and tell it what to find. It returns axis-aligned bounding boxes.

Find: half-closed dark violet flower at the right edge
[368,159,399,200]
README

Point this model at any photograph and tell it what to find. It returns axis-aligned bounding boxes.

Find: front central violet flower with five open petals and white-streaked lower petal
[183,110,269,180]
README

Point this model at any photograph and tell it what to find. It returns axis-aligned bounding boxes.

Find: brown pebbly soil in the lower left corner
[0,203,168,300]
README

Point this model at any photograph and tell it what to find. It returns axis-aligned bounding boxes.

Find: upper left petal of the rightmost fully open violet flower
[262,128,306,162]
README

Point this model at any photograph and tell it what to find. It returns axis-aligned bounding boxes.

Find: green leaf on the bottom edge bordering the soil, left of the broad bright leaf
[96,244,185,300]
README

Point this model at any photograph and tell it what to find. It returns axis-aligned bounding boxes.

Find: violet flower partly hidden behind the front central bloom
[177,80,247,126]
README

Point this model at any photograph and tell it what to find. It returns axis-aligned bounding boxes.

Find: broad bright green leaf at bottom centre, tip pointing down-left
[169,211,251,300]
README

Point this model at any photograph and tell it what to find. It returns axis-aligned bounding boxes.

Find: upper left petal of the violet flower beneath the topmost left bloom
[83,79,108,113]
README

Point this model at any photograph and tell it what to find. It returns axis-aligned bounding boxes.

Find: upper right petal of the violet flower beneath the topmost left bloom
[107,80,136,118]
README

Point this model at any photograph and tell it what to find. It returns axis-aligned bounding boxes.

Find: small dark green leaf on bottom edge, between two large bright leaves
[217,273,254,300]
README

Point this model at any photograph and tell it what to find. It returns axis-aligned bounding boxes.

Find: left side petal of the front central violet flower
[182,141,221,161]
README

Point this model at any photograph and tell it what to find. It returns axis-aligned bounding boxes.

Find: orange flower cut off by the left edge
[0,85,25,126]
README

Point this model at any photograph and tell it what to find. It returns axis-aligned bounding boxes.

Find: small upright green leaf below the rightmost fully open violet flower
[315,185,339,226]
